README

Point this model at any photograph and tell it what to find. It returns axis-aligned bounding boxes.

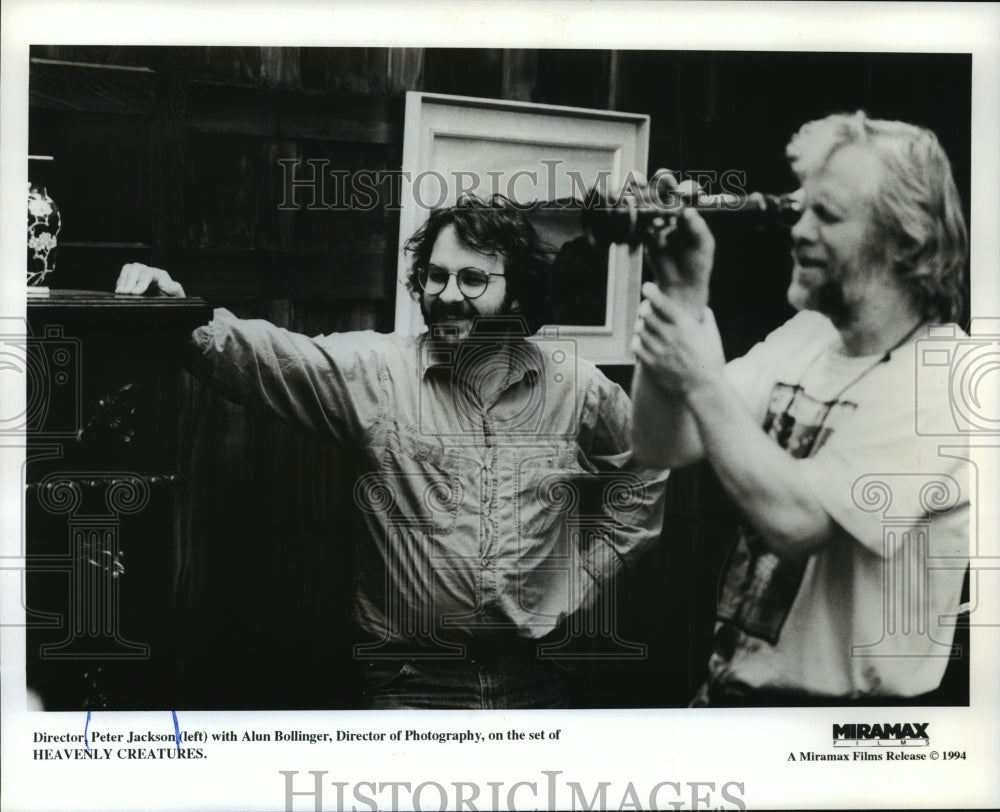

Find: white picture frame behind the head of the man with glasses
[395,91,649,365]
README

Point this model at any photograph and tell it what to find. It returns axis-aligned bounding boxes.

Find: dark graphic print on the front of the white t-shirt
[719,383,857,645]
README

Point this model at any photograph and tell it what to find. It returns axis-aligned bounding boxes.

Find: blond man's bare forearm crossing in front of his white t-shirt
[687,376,836,556]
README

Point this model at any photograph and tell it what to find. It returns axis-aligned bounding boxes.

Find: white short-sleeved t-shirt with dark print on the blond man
[709,312,971,698]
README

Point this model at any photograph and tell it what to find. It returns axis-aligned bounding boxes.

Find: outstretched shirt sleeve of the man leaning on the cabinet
[191,308,386,443]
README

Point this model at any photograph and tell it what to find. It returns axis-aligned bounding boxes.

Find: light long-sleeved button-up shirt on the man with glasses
[193,310,666,647]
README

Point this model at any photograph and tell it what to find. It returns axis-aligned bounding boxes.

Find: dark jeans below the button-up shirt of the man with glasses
[363,656,567,710]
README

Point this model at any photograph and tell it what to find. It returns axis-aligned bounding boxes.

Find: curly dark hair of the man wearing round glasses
[403,194,549,334]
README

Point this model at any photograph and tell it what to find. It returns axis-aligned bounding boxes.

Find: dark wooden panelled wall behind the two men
[29,46,971,708]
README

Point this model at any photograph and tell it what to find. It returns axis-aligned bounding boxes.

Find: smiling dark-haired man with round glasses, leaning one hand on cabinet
[116,196,666,709]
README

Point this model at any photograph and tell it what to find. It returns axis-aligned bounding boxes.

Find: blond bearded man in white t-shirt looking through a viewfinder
[633,113,970,706]
